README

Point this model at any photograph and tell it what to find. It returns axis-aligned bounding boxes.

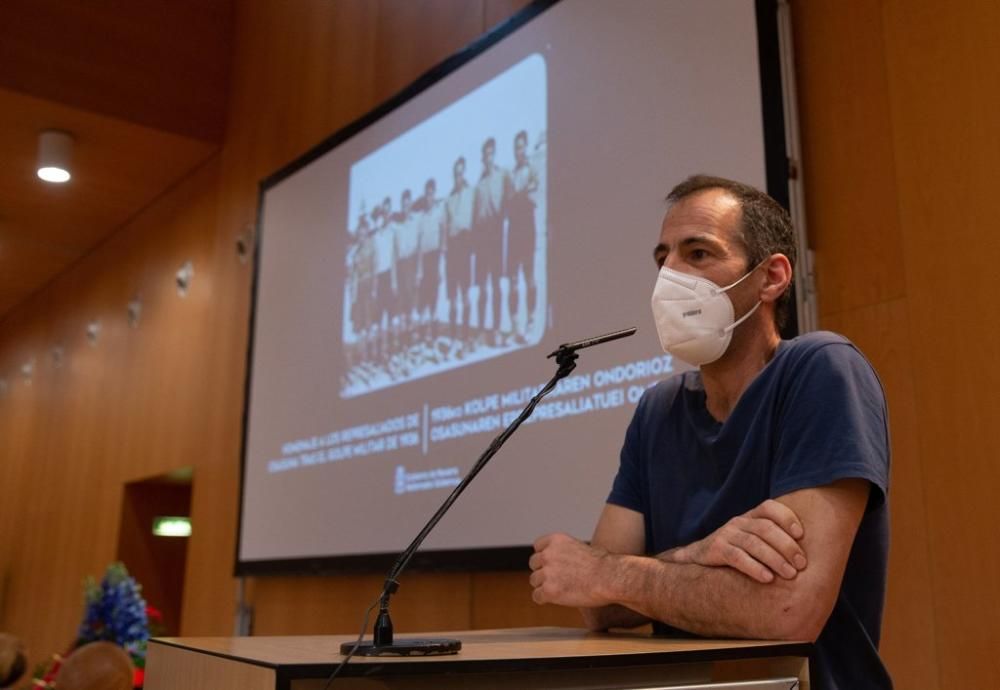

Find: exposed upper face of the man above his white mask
[653,189,749,292]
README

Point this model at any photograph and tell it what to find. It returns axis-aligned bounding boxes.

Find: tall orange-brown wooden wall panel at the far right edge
[884,0,1000,688]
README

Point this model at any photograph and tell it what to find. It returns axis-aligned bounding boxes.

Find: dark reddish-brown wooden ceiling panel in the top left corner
[0,0,233,142]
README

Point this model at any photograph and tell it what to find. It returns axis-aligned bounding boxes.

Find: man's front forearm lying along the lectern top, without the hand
[605,555,829,640]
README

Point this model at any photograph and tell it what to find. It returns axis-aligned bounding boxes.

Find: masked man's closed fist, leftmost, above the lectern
[528,534,612,608]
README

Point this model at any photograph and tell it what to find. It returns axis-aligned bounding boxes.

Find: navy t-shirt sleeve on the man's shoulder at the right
[771,342,889,505]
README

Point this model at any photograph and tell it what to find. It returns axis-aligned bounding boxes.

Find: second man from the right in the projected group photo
[472,137,510,345]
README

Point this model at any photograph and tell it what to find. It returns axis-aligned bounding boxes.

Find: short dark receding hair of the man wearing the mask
[666,175,797,330]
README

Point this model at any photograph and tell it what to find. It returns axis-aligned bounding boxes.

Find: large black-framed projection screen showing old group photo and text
[236,0,788,574]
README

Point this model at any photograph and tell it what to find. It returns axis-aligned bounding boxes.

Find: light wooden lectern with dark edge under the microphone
[145,628,812,690]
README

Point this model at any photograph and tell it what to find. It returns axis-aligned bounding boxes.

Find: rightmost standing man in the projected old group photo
[507,129,538,341]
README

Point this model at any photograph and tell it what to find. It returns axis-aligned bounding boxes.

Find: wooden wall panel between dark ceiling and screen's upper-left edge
[225,0,377,177]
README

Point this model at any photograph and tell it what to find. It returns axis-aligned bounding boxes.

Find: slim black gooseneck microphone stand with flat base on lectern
[340,346,584,652]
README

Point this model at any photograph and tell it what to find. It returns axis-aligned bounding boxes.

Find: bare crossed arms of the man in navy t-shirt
[529,479,869,640]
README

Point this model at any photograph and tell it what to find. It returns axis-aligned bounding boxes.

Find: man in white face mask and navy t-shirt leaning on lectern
[530,176,892,690]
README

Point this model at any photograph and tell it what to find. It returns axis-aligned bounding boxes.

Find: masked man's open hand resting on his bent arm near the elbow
[668,500,806,584]
